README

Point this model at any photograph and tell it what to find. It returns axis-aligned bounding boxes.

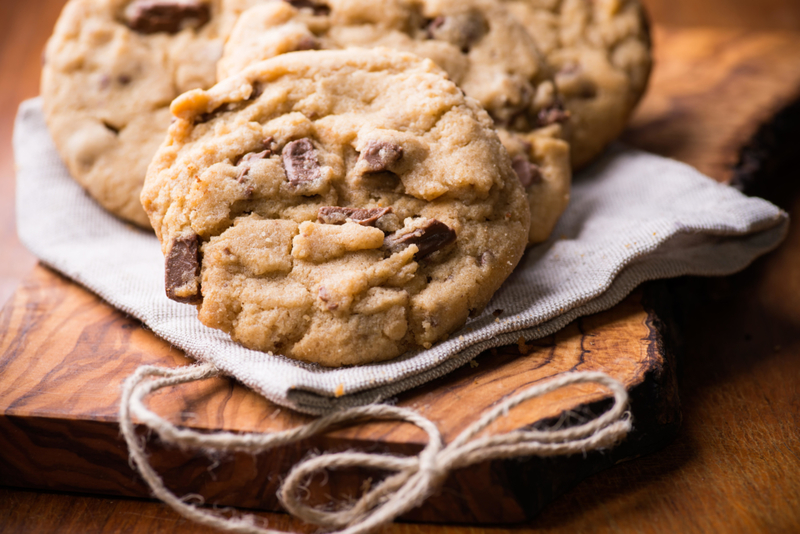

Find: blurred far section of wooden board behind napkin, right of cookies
[623,27,800,181]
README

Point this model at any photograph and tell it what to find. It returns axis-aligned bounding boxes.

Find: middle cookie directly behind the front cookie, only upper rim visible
[218,0,571,243]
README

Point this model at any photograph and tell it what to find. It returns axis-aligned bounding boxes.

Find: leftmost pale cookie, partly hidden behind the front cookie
[41,0,249,227]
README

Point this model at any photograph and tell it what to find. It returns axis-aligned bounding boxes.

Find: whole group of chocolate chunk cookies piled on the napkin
[42,0,650,366]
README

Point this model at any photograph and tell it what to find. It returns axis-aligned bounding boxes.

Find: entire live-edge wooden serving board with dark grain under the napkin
[0,28,800,523]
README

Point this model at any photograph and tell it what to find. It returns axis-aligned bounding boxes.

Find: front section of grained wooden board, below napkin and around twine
[0,267,679,523]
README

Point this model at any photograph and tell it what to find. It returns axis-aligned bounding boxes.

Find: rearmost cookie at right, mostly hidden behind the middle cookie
[503,0,652,169]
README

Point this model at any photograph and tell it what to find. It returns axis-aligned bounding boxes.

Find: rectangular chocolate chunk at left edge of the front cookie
[164,234,202,304]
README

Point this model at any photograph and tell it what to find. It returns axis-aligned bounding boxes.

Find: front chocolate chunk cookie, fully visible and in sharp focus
[142,49,530,366]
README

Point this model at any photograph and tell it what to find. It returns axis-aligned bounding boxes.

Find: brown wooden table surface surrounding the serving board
[0,0,800,534]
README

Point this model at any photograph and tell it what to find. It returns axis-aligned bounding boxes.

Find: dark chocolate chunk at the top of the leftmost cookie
[125,0,211,33]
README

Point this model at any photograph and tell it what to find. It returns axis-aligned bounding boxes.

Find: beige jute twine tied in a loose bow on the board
[120,364,631,534]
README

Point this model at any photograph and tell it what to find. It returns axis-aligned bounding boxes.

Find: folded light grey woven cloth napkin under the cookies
[14,99,788,414]
